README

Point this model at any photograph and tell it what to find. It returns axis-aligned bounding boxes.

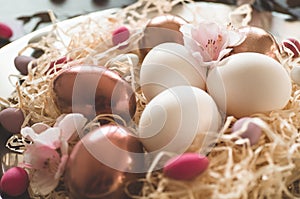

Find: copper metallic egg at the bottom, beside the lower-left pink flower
[65,125,144,199]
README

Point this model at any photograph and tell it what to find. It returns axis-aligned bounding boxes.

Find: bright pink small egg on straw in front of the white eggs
[163,153,209,180]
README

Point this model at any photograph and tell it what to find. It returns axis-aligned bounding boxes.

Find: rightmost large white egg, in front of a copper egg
[207,52,292,118]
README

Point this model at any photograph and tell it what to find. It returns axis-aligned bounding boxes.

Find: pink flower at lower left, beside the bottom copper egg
[21,114,87,195]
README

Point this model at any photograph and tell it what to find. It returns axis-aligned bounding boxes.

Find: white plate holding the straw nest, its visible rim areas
[0,2,300,97]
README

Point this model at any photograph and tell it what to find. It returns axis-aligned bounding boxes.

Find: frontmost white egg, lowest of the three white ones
[138,86,221,153]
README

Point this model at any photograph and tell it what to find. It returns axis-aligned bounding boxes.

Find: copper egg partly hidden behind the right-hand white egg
[231,27,279,60]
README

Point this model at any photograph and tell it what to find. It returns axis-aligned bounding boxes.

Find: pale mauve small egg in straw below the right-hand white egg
[232,117,262,145]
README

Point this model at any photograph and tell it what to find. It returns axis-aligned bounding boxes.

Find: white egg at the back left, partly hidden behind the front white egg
[140,43,205,101]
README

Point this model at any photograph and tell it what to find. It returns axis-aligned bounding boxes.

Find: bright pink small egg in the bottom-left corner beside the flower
[0,167,29,196]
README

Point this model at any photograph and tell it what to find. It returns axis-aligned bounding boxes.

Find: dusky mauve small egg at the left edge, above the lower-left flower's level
[0,108,24,133]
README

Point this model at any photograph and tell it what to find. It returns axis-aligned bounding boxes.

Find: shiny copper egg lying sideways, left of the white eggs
[52,66,136,121]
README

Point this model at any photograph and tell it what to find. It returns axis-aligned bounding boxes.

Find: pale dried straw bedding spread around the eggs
[0,0,300,199]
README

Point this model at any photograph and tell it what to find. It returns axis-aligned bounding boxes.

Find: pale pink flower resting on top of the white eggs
[180,21,245,67]
